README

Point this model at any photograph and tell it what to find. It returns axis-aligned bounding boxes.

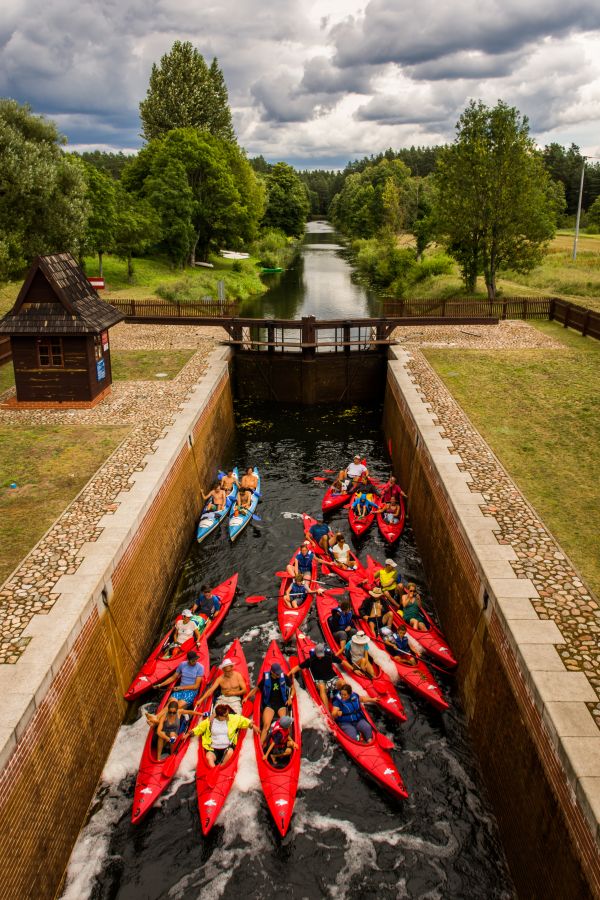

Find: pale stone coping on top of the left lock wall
[0,347,231,769]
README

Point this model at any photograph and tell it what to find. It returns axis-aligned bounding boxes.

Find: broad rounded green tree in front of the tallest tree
[122,128,264,265]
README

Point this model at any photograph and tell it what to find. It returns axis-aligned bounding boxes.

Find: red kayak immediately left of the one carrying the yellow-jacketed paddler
[131,641,210,825]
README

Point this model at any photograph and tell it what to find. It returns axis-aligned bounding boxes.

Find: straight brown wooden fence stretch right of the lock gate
[381,297,552,319]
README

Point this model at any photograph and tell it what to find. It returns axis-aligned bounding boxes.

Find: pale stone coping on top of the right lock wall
[389,349,600,843]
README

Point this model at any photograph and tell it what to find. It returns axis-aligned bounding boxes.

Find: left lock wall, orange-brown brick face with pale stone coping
[0,349,234,900]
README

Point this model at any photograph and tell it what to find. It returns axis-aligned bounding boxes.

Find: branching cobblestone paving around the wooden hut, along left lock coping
[0,325,224,664]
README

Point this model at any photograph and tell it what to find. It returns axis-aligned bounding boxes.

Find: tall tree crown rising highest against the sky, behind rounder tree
[140,41,235,141]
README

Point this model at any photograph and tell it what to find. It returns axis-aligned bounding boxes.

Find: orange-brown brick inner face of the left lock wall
[0,351,234,900]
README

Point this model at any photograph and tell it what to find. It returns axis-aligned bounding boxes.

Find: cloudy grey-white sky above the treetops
[0,0,600,168]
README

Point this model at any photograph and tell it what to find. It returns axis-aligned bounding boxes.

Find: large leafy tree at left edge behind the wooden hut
[0,100,88,278]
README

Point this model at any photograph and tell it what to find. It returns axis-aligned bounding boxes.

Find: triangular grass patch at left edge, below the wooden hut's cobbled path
[0,425,130,584]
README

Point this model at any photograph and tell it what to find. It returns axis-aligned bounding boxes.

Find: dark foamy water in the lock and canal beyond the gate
[64,225,514,900]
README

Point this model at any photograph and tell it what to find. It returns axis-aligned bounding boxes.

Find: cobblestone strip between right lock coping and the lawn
[409,348,600,727]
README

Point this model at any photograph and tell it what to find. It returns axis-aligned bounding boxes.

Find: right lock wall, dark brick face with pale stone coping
[384,351,600,898]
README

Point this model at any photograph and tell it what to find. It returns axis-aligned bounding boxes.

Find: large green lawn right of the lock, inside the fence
[423,322,600,595]
